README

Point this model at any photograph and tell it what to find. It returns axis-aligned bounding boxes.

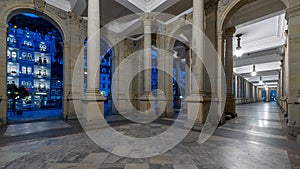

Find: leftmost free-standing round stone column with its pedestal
[83,0,105,129]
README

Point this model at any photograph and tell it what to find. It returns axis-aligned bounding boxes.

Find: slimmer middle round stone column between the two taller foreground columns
[140,13,154,111]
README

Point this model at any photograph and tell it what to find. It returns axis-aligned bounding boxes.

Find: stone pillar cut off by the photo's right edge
[286,4,300,135]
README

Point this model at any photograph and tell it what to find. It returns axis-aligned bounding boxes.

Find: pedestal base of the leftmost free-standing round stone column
[80,90,106,131]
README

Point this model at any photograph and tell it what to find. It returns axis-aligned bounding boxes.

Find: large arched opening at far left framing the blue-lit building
[7,10,64,122]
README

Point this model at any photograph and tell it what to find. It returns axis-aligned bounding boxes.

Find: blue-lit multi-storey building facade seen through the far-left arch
[7,13,63,115]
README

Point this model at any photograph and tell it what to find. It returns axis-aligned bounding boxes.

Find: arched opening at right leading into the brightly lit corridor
[218,0,287,109]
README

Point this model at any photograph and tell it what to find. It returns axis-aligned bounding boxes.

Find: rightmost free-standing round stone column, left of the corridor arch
[186,0,207,130]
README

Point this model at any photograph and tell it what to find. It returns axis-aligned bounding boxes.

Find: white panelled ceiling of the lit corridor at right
[233,14,287,88]
